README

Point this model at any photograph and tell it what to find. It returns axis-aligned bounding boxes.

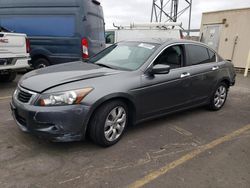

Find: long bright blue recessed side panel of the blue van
[0,15,75,37]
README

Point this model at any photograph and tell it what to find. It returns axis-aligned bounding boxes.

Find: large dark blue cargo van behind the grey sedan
[0,0,105,68]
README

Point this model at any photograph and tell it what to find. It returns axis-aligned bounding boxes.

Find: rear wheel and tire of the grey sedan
[208,82,228,111]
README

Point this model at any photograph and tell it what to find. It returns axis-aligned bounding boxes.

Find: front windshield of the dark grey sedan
[89,42,159,71]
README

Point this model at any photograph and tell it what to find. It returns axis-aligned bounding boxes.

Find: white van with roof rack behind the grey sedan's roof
[105,23,183,46]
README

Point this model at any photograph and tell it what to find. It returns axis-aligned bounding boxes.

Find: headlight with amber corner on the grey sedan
[38,88,93,106]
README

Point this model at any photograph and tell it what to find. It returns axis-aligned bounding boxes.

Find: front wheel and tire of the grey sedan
[89,100,128,147]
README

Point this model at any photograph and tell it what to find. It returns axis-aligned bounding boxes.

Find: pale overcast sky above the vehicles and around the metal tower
[100,0,250,29]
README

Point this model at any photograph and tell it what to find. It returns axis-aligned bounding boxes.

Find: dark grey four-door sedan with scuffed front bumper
[11,39,235,146]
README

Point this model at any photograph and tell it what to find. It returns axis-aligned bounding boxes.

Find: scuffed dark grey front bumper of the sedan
[10,98,90,142]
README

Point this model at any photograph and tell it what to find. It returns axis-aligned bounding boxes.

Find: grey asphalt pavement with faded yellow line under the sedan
[0,74,250,188]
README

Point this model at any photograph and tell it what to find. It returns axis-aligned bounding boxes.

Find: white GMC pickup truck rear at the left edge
[0,29,30,82]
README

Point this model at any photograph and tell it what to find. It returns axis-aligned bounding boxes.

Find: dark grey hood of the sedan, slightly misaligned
[19,61,122,93]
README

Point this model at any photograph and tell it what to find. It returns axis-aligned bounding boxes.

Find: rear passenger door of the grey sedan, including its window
[185,44,219,104]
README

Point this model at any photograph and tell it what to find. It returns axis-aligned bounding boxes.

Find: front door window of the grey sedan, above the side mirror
[154,45,184,69]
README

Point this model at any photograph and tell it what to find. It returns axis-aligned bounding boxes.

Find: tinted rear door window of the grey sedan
[186,44,213,65]
